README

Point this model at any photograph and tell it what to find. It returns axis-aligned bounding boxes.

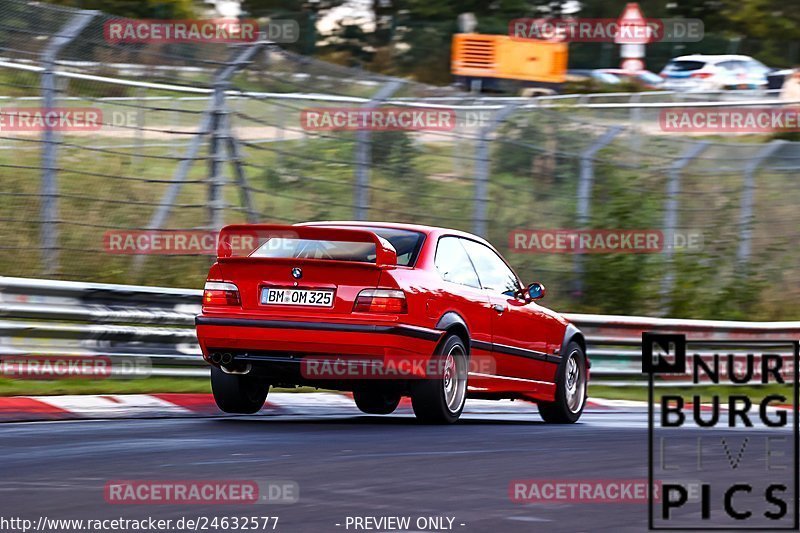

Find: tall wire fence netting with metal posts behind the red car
[0,0,800,318]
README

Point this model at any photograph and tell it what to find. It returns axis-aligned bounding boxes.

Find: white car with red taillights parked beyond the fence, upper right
[661,54,770,91]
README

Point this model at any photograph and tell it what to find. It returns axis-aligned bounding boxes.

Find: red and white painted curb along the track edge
[0,392,646,422]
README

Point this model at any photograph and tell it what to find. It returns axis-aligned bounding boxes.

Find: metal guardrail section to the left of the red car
[0,276,208,377]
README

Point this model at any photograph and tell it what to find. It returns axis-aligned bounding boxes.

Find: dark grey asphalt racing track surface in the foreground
[0,411,792,532]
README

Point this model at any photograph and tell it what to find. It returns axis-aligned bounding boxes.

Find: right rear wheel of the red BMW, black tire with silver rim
[411,335,469,424]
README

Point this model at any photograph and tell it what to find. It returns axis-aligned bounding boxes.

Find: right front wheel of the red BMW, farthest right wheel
[539,342,589,424]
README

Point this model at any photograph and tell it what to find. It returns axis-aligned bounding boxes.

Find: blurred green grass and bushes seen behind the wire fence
[0,100,800,320]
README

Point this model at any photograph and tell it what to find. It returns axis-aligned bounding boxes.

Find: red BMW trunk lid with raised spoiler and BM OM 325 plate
[217,225,397,318]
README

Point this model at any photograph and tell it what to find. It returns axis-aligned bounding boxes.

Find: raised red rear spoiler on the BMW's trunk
[217,224,397,267]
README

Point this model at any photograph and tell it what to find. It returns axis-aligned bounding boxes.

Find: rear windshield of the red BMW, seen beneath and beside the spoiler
[250,226,423,266]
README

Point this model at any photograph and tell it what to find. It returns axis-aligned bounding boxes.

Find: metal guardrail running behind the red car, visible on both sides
[0,276,800,385]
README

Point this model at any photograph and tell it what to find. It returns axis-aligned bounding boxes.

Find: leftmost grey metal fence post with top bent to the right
[41,11,98,276]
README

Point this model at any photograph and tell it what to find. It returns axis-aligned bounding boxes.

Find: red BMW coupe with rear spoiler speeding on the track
[196,222,589,423]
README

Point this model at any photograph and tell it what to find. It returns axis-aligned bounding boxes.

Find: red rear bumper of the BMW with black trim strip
[195,315,444,383]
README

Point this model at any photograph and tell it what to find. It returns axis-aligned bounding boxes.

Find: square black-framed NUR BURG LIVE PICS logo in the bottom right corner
[642,333,800,531]
